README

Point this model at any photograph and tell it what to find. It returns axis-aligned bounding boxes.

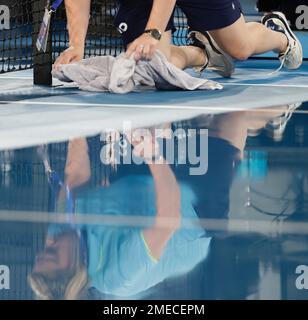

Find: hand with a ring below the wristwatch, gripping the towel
[126,33,159,61]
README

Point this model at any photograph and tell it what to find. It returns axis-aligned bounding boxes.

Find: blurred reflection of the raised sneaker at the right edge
[265,102,302,142]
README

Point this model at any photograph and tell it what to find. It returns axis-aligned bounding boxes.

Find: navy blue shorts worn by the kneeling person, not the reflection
[115,0,242,45]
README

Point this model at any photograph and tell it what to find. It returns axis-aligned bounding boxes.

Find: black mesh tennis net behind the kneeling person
[0,0,187,83]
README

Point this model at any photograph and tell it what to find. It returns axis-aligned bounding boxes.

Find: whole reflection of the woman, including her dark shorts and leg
[30,106,294,299]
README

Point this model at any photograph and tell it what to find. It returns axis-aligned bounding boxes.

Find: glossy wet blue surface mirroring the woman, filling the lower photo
[0,94,308,300]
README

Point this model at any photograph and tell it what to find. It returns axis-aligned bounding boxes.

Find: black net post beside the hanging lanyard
[32,0,52,86]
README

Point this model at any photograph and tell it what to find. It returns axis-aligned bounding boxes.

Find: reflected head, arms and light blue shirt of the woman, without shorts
[30,136,210,299]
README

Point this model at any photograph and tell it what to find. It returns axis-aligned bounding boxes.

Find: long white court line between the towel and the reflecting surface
[0,100,308,114]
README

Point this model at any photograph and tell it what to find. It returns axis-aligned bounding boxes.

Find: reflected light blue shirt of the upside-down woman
[76,175,210,297]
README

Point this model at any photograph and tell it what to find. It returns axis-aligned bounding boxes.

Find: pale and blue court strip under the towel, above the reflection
[0,60,308,147]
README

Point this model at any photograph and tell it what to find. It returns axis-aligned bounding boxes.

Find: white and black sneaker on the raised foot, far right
[262,12,303,70]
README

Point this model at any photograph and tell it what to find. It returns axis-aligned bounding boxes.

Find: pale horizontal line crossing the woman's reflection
[0,211,308,237]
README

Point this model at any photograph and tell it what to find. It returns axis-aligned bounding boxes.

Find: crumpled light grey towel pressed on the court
[52,51,222,93]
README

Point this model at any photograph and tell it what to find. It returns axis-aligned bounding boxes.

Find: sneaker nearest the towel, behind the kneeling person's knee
[188,31,234,78]
